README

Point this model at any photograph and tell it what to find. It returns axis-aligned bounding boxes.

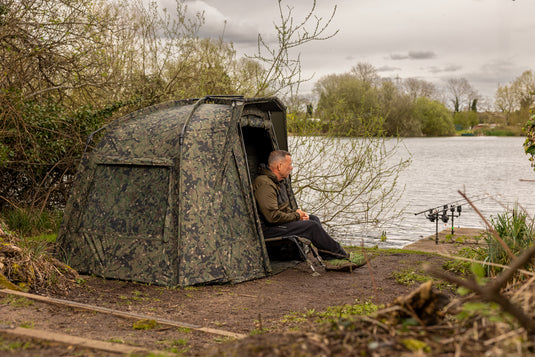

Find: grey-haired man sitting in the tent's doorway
[253,150,362,268]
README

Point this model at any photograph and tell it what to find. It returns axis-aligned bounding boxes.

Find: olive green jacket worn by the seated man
[253,168,300,226]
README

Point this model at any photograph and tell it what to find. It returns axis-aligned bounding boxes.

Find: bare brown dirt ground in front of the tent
[0,228,486,356]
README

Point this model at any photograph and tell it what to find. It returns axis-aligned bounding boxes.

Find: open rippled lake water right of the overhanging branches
[298,136,535,248]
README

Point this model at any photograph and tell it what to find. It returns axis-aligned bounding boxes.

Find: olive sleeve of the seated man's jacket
[254,180,300,225]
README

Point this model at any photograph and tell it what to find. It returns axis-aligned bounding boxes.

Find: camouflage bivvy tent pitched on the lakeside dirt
[56,97,302,286]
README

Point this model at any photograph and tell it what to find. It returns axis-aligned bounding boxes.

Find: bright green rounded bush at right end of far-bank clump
[413,98,455,136]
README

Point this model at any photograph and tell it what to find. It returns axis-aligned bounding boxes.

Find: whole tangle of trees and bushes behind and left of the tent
[0,0,344,209]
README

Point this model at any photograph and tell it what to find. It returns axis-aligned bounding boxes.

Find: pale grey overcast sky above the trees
[160,0,535,104]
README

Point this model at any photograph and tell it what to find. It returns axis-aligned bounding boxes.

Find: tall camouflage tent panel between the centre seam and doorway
[179,102,265,285]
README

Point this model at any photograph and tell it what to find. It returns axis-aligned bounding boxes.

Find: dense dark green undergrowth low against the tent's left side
[0,92,124,209]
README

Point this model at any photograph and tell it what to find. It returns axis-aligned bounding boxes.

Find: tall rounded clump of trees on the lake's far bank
[314,63,455,136]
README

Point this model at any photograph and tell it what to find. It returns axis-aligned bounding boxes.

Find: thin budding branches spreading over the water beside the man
[290,118,410,234]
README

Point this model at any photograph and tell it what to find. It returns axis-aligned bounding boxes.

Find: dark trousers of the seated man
[262,215,348,259]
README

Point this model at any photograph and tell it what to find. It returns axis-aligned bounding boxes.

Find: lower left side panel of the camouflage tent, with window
[57,161,176,284]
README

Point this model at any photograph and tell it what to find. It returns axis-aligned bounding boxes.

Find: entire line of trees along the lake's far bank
[290,63,535,137]
